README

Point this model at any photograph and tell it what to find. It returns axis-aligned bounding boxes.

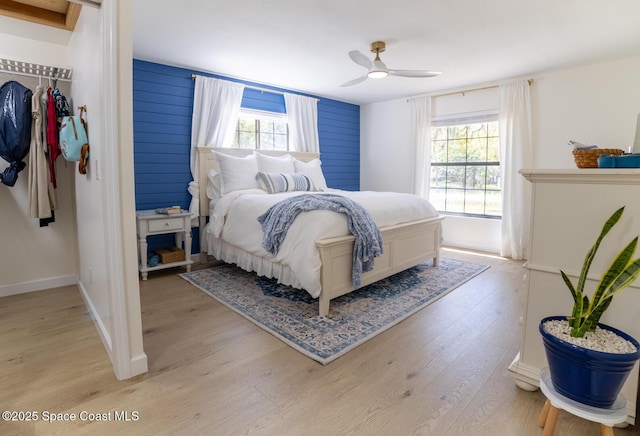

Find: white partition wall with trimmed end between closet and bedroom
[69,0,147,378]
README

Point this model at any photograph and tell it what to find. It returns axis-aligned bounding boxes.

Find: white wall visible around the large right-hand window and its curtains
[360,56,640,253]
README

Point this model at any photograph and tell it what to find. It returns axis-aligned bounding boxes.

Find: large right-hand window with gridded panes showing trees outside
[429,112,502,218]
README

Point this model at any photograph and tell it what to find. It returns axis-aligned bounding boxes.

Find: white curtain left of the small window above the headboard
[189,76,244,218]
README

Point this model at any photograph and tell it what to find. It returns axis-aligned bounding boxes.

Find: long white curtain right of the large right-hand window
[499,81,532,259]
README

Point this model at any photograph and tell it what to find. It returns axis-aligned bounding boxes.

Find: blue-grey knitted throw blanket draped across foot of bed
[258,194,382,287]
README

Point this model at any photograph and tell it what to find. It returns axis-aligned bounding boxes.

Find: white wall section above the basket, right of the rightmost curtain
[531,56,640,168]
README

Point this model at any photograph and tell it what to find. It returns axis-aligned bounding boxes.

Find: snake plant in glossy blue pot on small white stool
[539,207,640,408]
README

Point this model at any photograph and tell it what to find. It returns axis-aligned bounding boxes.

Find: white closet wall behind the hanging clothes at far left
[0,29,78,297]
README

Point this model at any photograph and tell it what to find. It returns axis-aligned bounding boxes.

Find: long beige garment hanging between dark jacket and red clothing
[28,86,57,227]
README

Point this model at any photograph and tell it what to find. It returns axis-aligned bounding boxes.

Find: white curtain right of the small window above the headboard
[284,93,320,153]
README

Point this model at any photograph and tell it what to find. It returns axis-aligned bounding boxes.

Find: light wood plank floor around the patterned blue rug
[0,250,640,436]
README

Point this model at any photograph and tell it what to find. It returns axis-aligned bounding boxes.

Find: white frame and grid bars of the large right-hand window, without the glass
[429,110,503,220]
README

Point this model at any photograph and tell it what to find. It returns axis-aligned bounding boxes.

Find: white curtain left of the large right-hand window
[411,96,431,198]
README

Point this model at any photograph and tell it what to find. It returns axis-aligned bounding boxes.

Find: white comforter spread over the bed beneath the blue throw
[207,189,437,298]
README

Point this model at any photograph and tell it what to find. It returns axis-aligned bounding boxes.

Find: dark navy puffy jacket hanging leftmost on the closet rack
[0,80,33,186]
